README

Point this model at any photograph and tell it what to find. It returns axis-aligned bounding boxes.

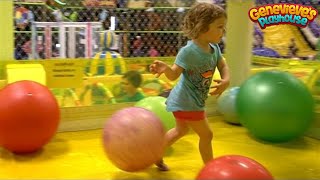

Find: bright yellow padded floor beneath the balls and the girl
[0,116,320,179]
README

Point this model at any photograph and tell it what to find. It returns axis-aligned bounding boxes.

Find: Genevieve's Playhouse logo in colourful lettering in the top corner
[249,4,318,29]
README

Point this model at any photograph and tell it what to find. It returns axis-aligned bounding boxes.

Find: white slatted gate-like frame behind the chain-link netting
[32,22,102,59]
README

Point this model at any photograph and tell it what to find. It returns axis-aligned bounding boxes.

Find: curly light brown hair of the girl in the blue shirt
[182,3,227,39]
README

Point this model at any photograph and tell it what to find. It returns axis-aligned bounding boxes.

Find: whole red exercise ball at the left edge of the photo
[0,81,60,153]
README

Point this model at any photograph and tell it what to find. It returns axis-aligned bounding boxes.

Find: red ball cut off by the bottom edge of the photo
[197,155,273,180]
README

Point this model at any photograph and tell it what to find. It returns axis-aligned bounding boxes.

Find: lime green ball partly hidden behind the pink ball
[135,96,176,131]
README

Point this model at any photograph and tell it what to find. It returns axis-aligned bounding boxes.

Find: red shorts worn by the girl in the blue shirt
[172,111,206,121]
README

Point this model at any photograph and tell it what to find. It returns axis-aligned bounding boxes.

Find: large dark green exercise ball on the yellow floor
[236,71,315,142]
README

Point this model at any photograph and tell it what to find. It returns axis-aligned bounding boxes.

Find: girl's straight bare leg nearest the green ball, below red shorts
[187,119,213,164]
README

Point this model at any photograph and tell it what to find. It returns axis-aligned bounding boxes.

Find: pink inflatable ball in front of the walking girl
[103,107,165,172]
